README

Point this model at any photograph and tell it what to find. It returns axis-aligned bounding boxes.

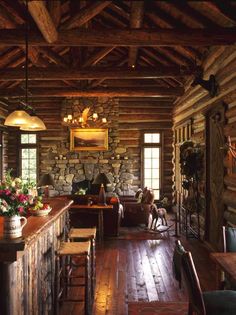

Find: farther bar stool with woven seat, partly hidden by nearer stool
[68,227,97,297]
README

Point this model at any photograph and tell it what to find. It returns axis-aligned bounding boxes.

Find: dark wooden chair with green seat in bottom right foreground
[182,252,236,315]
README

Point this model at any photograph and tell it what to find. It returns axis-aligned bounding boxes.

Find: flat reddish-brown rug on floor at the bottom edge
[128,301,188,315]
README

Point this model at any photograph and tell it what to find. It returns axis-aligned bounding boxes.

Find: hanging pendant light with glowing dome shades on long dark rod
[4,0,46,131]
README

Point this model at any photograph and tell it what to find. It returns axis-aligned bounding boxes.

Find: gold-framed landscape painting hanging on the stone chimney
[70,128,108,151]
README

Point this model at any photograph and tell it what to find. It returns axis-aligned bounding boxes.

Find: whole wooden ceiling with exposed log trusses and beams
[0,0,236,105]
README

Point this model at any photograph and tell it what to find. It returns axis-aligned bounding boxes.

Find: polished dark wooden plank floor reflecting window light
[61,232,215,315]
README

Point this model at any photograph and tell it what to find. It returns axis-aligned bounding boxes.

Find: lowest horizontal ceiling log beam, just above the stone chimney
[0,87,184,97]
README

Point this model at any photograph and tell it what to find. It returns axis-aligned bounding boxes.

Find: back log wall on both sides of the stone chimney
[9,98,173,200]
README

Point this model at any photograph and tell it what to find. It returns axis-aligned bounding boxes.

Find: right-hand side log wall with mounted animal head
[173,46,236,235]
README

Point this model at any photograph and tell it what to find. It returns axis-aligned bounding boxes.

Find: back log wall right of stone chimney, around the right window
[119,98,173,200]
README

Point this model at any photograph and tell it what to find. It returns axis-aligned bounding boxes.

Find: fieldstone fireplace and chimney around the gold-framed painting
[41,98,137,196]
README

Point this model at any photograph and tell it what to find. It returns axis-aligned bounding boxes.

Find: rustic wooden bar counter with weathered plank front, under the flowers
[0,198,73,315]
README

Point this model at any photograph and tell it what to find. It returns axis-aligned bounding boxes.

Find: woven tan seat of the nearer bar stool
[57,241,90,256]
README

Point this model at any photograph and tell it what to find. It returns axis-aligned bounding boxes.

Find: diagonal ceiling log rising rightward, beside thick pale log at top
[62,1,111,29]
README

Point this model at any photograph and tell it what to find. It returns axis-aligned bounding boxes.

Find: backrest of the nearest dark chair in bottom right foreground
[182,252,206,315]
